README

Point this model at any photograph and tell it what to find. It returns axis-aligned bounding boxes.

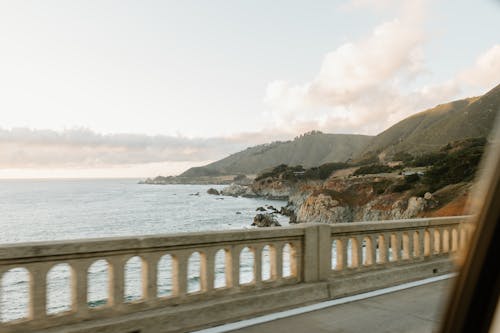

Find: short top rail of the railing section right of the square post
[331,215,473,236]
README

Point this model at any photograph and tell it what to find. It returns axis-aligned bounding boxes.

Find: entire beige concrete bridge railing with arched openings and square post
[0,217,472,333]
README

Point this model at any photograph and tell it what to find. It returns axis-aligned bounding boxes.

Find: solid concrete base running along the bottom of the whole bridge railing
[31,258,454,333]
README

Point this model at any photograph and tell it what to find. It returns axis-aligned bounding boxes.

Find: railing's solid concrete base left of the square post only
[38,282,328,333]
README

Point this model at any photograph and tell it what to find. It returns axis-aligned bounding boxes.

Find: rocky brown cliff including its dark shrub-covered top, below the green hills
[247,138,487,223]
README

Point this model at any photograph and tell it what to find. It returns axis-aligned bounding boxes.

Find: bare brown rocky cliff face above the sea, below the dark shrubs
[252,174,471,224]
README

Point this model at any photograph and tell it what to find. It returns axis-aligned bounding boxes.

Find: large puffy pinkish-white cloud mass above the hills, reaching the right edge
[265,0,500,134]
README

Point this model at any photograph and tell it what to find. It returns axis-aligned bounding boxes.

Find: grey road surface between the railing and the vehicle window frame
[216,279,453,333]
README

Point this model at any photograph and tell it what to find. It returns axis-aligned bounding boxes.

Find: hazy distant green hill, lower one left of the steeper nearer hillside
[180,131,372,177]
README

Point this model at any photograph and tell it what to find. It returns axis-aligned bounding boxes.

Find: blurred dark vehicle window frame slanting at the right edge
[441,117,500,333]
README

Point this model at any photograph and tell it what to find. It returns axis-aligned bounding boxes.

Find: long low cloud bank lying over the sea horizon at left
[0,128,296,172]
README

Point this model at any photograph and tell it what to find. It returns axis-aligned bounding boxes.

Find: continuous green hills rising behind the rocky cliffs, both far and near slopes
[145,81,500,184]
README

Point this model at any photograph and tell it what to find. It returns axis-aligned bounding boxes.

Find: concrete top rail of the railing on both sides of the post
[0,216,471,265]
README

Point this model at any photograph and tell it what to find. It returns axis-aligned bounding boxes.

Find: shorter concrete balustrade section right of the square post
[331,218,472,276]
